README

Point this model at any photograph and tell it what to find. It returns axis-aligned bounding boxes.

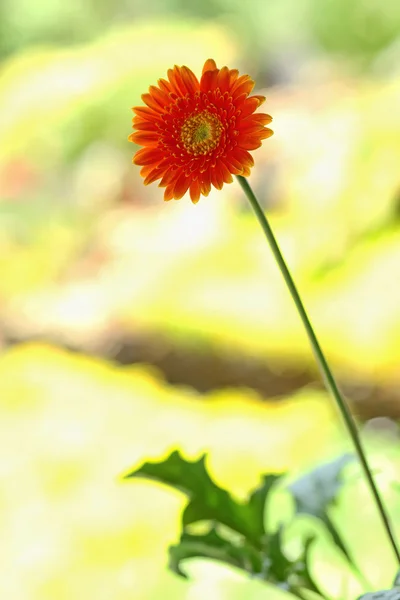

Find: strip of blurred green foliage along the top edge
[0,0,400,72]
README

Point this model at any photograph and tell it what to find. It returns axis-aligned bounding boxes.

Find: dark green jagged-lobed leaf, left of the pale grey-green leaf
[127,451,328,600]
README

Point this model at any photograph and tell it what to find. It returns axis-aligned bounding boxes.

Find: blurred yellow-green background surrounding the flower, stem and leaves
[0,0,400,600]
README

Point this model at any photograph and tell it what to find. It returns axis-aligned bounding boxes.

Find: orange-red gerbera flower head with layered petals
[128,59,273,202]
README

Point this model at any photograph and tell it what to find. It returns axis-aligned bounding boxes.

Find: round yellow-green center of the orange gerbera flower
[181,110,223,156]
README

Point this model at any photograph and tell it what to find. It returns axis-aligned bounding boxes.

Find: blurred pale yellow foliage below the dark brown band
[0,344,340,600]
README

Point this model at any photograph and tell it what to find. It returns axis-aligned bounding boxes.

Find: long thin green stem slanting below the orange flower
[237,176,400,565]
